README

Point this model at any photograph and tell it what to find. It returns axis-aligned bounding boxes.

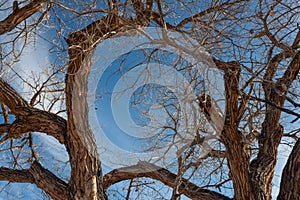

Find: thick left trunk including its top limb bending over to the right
[66,2,149,199]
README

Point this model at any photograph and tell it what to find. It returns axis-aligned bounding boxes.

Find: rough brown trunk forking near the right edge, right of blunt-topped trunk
[250,51,300,200]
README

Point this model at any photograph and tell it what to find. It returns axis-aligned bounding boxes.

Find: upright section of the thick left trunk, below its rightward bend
[66,43,106,200]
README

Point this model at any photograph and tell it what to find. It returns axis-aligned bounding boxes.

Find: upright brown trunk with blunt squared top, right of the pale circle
[214,59,254,200]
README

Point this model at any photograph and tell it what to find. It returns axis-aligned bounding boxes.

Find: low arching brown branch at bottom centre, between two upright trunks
[103,162,230,200]
